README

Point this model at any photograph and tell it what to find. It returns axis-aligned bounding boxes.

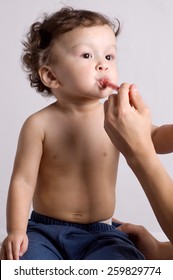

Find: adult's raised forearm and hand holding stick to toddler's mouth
[104,83,173,243]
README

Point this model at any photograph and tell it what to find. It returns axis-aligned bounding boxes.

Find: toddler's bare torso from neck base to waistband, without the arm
[30,103,118,223]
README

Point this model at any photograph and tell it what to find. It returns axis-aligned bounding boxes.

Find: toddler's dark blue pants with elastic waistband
[20,211,145,260]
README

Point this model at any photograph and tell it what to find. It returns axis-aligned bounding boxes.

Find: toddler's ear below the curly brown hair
[38,65,59,89]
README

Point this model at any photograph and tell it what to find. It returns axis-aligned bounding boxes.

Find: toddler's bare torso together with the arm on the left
[2,103,118,258]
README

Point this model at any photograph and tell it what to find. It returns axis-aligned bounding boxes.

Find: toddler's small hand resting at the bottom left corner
[0,230,28,260]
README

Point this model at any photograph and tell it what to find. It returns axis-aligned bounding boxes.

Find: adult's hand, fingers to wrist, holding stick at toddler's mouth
[104,83,153,160]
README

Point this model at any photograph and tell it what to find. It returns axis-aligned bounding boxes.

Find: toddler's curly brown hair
[22,7,120,96]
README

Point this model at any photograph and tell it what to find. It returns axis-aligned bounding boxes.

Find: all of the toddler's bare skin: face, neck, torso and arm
[1,25,119,260]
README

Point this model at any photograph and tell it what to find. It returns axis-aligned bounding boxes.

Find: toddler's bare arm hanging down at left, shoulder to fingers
[3,117,43,259]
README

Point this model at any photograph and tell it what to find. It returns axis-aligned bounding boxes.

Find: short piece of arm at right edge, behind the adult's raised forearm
[152,124,173,154]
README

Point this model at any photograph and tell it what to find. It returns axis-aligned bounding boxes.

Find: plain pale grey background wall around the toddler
[0,0,173,240]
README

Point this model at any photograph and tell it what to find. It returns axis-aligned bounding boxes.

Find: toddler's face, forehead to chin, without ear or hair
[52,25,117,99]
